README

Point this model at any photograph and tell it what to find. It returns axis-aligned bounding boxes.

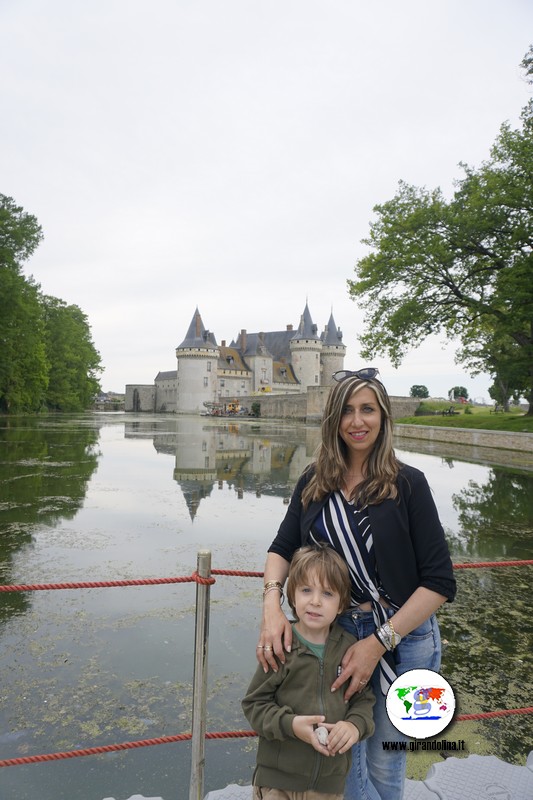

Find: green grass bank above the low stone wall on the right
[395,400,533,433]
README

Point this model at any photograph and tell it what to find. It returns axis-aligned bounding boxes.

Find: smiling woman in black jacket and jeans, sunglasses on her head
[257,367,455,800]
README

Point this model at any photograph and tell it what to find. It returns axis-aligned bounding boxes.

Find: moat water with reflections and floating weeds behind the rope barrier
[0,414,533,800]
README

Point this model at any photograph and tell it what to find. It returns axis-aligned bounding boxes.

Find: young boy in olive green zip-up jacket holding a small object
[242,546,374,800]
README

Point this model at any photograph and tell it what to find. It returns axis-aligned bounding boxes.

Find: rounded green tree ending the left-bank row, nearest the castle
[43,296,102,411]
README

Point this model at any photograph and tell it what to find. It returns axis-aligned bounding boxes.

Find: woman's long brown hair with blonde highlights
[302,376,401,507]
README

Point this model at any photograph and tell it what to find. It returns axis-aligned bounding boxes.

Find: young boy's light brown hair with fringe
[287,544,351,617]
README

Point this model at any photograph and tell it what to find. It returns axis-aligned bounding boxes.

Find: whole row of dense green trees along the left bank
[0,194,102,413]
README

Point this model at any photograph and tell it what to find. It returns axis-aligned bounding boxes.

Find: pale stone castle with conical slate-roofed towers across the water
[125,303,346,414]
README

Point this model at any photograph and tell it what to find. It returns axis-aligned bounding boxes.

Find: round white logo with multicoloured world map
[387,669,455,739]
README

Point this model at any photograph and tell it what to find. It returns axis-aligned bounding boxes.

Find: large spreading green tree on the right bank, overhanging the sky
[348,50,533,414]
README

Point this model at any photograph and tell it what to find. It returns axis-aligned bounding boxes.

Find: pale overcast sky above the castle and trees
[0,0,533,402]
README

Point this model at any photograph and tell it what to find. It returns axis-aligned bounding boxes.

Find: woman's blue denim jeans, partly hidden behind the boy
[339,609,441,800]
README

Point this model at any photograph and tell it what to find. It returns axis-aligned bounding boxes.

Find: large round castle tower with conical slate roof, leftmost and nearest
[176,308,220,414]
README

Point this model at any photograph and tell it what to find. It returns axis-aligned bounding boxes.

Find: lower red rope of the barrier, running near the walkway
[0,706,533,768]
